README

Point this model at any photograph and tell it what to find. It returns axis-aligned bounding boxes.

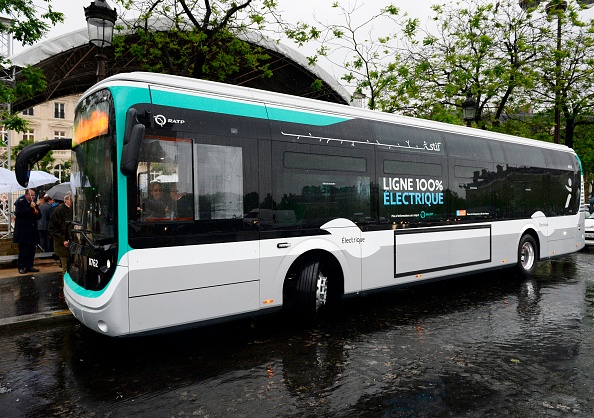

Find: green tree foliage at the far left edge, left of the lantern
[0,0,64,132]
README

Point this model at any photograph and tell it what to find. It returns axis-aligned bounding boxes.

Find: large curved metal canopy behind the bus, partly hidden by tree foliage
[9,28,351,111]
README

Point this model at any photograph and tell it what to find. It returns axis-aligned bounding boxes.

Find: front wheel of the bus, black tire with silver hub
[294,260,328,322]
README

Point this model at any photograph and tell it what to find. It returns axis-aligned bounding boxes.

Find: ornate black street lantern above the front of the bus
[84,0,118,81]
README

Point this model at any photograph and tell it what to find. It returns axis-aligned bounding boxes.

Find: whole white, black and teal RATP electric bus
[17,72,585,336]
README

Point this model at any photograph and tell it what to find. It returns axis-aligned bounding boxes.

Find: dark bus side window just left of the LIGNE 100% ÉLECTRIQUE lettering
[272,143,372,229]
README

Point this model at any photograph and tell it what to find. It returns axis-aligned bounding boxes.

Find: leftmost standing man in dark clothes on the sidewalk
[12,189,41,274]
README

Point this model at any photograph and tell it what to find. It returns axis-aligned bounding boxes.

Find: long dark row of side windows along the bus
[130,130,579,246]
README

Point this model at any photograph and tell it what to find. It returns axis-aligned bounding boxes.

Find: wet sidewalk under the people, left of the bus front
[0,258,73,332]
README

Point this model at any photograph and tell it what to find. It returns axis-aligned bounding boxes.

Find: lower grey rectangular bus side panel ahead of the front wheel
[130,281,260,333]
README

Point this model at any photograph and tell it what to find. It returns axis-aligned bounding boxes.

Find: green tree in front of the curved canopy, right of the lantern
[114,0,290,81]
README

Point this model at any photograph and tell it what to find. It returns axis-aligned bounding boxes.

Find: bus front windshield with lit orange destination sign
[70,90,116,246]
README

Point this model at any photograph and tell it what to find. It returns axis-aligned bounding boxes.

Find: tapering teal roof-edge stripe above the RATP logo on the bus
[151,88,349,126]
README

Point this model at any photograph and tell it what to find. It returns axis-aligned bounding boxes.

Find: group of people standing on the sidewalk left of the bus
[13,189,72,274]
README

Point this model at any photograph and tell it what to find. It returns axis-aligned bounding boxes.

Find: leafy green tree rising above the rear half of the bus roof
[404,0,546,127]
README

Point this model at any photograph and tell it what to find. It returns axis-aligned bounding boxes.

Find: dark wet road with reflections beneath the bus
[0,250,594,417]
